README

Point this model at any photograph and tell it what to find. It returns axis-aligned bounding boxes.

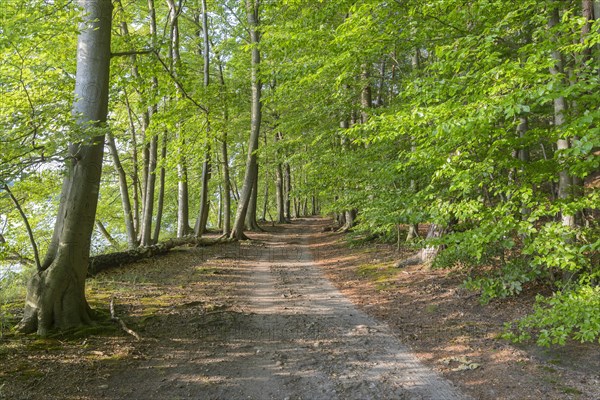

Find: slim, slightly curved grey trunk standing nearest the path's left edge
[230,0,262,240]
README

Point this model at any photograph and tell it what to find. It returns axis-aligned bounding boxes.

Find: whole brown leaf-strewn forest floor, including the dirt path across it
[0,218,600,400]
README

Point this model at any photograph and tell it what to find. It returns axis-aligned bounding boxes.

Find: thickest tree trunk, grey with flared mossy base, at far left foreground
[18,0,112,335]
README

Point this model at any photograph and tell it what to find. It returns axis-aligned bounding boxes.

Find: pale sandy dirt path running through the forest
[91,219,468,400]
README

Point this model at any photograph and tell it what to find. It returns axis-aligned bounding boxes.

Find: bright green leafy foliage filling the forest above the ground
[0,0,600,345]
